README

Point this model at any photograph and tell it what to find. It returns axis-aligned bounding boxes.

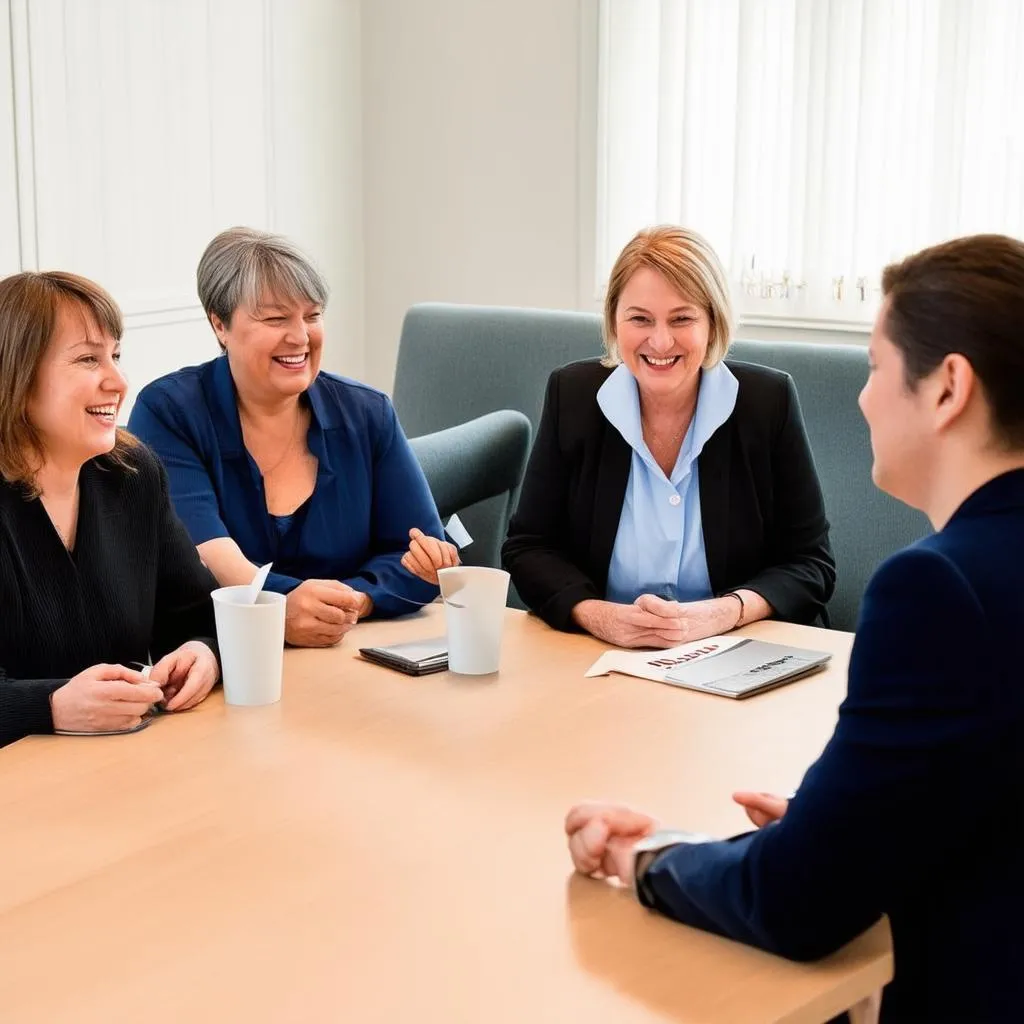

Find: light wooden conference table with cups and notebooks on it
[0,605,892,1024]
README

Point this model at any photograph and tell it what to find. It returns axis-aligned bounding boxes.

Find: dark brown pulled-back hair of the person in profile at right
[882,234,1024,450]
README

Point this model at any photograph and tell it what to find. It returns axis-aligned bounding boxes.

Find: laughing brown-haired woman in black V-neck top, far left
[0,272,219,745]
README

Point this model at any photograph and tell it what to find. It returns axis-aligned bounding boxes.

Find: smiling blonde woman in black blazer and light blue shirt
[502,226,836,647]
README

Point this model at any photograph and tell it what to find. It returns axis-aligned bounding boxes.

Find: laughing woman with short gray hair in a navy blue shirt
[129,227,454,646]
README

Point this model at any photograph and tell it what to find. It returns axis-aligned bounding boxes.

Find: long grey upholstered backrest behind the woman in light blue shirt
[394,303,929,630]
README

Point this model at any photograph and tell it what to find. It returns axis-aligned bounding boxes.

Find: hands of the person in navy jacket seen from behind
[565,792,788,886]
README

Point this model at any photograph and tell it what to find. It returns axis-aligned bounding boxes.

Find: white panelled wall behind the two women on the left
[0,0,362,415]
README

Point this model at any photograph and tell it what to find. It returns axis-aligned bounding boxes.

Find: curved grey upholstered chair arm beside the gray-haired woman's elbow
[410,409,530,566]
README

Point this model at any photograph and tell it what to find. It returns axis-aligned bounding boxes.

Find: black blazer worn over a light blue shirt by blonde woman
[502,360,836,630]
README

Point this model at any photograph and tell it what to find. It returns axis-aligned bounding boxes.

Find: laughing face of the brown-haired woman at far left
[27,301,128,465]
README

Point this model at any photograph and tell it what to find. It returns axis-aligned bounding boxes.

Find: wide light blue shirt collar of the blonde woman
[597,362,739,481]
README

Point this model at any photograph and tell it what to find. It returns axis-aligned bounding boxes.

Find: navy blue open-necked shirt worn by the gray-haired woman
[128,355,443,616]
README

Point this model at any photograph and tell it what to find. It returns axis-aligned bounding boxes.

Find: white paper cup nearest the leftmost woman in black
[212,585,286,708]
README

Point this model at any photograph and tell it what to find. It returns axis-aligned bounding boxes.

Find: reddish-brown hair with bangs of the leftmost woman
[0,270,138,497]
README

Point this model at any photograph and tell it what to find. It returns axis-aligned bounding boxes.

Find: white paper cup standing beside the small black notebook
[437,565,509,676]
